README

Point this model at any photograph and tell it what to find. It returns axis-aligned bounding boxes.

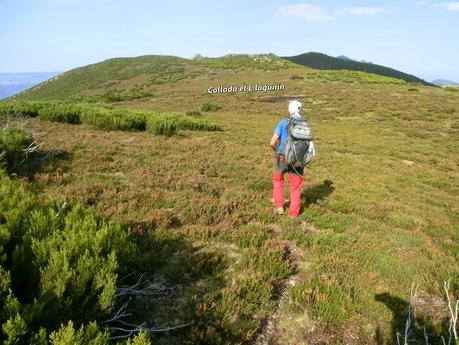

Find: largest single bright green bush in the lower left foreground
[0,171,128,344]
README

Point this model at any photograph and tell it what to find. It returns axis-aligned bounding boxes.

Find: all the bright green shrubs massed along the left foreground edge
[0,124,159,345]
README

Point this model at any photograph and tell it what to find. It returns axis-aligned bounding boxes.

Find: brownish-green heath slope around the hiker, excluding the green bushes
[0,57,459,344]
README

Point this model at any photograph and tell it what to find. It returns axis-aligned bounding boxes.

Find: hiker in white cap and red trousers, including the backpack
[270,101,315,218]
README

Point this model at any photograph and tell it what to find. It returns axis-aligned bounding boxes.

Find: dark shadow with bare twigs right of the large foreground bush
[116,227,228,344]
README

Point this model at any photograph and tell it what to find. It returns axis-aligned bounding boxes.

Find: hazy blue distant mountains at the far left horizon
[0,72,59,99]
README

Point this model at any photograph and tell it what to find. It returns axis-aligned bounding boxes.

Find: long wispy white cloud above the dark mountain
[279,3,387,22]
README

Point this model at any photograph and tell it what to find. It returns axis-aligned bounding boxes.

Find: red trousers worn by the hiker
[273,169,303,217]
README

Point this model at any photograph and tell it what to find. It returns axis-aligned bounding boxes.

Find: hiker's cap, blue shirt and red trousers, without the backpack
[270,101,304,218]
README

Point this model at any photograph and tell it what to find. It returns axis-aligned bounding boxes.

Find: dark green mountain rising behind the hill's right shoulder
[283,52,436,86]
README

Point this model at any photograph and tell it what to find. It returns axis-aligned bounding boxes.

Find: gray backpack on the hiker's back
[284,118,313,167]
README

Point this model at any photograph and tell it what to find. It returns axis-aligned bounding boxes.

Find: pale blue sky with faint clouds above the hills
[0,0,459,82]
